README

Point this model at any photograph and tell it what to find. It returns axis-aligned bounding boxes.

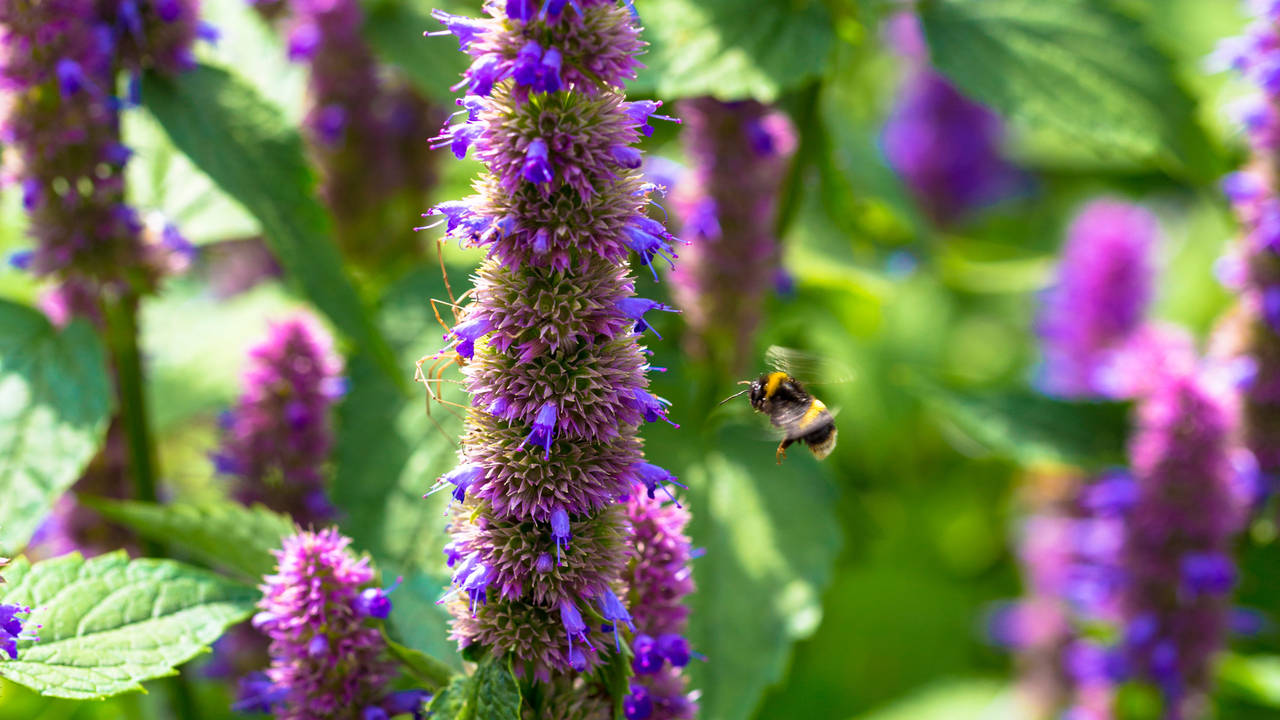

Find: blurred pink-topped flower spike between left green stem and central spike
[214,315,342,524]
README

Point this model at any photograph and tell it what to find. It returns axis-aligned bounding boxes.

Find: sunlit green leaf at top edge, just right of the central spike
[630,0,833,102]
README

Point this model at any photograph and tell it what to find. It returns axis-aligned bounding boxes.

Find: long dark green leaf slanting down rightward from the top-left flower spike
[142,65,401,382]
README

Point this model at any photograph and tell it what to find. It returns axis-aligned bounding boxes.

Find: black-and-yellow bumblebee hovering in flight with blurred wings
[721,346,852,465]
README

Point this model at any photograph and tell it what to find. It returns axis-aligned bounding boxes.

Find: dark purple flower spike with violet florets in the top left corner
[0,0,202,304]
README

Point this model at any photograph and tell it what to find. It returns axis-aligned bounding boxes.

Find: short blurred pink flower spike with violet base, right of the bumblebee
[1037,200,1158,397]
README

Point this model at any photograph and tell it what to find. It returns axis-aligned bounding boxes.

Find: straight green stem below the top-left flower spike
[104,292,156,502]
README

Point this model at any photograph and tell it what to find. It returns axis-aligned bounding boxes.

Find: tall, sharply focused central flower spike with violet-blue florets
[430,0,692,720]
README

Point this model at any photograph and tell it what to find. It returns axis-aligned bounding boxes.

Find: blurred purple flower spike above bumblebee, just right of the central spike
[671,97,796,372]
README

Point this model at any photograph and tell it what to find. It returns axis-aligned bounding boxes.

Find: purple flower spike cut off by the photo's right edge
[1210,0,1280,515]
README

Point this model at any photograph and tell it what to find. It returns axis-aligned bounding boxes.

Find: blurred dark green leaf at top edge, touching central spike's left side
[364,0,470,101]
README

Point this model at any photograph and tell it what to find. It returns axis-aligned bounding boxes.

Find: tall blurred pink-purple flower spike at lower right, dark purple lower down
[1121,373,1242,717]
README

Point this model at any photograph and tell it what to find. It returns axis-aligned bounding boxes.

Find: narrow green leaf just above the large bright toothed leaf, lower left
[81,497,296,582]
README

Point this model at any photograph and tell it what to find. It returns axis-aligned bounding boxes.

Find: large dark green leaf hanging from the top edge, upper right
[920,0,1220,179]
